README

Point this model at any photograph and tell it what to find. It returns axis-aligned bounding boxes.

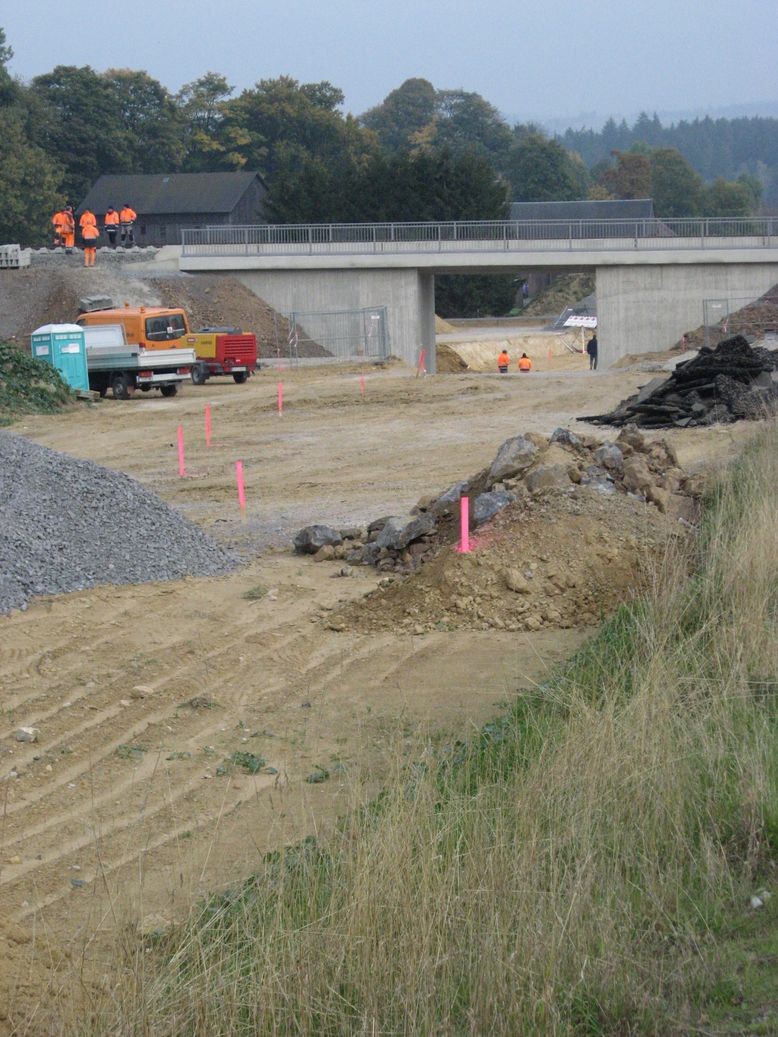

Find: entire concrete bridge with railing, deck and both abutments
[179,218,778,370]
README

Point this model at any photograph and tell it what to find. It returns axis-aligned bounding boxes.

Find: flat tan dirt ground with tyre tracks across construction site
[0,365,754,1033]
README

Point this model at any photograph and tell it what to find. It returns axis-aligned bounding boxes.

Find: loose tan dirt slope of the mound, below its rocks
[338,493,680,634]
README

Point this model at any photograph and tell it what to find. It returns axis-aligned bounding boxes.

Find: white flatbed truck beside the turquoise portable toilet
[83,325,197,399]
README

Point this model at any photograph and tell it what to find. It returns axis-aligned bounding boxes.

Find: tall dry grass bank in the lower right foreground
[88,425,778,1037]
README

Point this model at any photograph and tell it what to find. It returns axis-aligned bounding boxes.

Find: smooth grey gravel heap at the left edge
[0,432,238,613]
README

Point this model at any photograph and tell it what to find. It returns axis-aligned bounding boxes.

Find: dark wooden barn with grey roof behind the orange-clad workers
[78,171,268,247]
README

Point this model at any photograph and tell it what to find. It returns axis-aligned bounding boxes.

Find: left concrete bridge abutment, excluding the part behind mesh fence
[230,268,436,374]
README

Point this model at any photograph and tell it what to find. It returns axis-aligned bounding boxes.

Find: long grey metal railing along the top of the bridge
[183,217,778,256]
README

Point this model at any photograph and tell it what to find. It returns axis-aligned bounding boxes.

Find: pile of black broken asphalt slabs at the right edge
[579,335,778,428]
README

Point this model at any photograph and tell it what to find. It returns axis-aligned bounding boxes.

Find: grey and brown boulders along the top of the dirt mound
[295,426,700,572]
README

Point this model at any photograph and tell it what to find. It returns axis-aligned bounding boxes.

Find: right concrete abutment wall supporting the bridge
[596,262,778,367]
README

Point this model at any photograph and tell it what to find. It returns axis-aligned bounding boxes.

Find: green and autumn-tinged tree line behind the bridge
[0,29,778,312]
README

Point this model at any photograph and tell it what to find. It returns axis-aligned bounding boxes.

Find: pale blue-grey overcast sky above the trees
[0,0,778,128]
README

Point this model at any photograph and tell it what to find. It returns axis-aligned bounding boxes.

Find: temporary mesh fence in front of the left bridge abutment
[261,306,389,363]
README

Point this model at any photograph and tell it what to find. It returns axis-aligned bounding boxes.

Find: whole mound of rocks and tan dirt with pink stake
[295,427,701,633]
